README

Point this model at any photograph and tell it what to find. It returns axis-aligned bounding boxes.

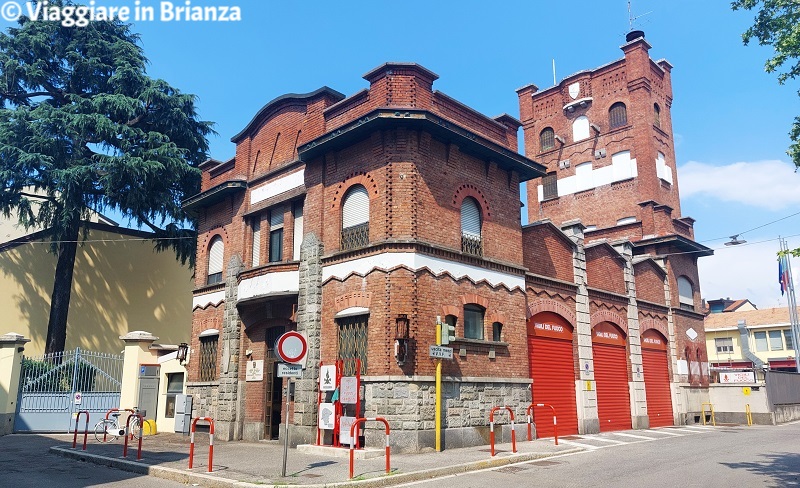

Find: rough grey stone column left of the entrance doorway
[214,254,244,441]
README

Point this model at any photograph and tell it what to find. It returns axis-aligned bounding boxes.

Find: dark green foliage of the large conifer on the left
[0,0,213,264]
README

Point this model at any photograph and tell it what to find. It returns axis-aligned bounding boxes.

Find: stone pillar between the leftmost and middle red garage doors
[561,220,600,434]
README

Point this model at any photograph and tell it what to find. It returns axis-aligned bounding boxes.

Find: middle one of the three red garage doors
[592,322,632,432]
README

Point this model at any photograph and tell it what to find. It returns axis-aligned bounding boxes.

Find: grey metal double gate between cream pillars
[14,348,123,432]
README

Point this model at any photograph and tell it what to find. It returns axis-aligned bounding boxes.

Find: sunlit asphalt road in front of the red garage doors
[396,423,800,488]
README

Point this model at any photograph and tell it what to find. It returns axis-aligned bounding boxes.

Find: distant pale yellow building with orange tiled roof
[704,308,797,371]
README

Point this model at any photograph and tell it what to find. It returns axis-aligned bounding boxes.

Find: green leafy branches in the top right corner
[731,0,800,167]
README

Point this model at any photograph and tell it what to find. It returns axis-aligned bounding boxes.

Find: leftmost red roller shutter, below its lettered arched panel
[528,336,578,437]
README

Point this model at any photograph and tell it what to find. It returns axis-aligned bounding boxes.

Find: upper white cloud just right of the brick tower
[678,160,800,211]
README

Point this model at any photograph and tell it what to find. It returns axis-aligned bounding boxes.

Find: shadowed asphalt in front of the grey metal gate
[0,434,186,488]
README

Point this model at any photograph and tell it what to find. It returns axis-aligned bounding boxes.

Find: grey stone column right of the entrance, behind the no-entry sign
[292,232,323,445]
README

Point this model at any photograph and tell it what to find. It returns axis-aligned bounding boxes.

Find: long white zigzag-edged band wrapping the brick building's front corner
[322,252,525,290]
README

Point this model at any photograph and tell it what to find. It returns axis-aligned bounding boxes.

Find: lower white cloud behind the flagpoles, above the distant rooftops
[698,235,800,310]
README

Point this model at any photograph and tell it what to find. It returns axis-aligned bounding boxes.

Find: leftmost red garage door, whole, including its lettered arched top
[528,312,578,437]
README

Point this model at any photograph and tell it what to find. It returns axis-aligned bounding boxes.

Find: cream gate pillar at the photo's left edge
[0,332,31,436]
